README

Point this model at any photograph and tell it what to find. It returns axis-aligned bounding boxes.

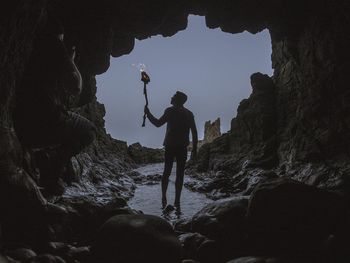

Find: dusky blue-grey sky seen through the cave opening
[96,15,273,148]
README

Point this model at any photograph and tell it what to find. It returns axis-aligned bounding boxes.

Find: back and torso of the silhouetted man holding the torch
[164,106,194,147]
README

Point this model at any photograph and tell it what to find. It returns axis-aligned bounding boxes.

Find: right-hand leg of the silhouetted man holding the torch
[174,147,187,208]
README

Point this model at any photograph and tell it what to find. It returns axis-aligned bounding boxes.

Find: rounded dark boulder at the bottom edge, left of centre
[92,215,181,263]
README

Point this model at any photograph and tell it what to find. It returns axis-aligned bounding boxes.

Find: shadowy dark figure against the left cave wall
[14,17,96,195]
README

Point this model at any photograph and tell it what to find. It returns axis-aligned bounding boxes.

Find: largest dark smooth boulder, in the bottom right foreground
[247,178,349,254]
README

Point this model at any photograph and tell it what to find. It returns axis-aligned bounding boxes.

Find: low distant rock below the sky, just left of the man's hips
[128,143,164,164]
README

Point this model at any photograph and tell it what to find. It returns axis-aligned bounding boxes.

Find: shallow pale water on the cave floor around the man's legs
[128,163,212,221]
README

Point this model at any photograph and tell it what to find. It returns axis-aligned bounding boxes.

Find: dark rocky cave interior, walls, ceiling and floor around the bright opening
[0,0,350,262]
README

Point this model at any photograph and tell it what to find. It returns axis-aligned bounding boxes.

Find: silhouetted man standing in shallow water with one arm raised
[145,91,198,208]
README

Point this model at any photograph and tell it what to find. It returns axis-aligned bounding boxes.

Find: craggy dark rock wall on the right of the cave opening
[189,1,349,195]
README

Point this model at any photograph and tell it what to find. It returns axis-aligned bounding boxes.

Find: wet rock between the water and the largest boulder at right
[175,197,248,262]
